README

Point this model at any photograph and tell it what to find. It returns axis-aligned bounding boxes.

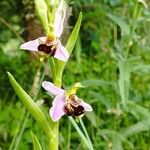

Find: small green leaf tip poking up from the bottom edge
[30,131,42,150]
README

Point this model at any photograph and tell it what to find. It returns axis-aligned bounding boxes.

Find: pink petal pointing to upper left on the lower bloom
[42,81,65,95]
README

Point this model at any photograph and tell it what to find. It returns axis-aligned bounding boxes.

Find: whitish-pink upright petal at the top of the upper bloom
[54,0,66,37]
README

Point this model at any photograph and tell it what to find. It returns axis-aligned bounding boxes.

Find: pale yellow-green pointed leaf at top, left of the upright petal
[35,0,50,34]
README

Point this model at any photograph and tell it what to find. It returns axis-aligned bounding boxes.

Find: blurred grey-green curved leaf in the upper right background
[107,13,130,36]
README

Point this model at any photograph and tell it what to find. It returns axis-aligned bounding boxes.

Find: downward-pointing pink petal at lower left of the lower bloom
[49,95,65,122]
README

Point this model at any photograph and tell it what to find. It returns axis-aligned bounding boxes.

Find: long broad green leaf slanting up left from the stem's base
[7,72,53,137]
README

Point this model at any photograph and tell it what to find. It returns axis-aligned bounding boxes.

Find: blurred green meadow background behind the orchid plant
[0,0,150,150]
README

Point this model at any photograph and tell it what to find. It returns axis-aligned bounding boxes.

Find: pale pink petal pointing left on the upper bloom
[20,37,46,51]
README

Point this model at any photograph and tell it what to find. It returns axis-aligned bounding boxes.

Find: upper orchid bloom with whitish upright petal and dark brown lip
[20,0,69,61]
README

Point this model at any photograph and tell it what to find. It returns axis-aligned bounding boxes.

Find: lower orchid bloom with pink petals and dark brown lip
[42,81,92,122]
